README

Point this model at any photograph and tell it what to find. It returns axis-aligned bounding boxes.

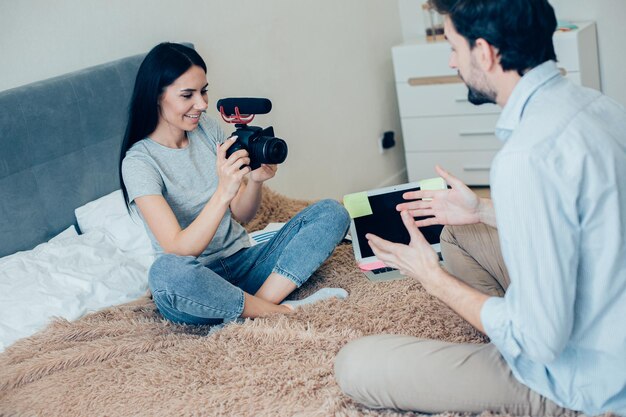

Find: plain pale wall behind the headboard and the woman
[0,0,406,198]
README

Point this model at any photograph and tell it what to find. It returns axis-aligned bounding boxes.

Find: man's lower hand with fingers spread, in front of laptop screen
[365,211,441,292]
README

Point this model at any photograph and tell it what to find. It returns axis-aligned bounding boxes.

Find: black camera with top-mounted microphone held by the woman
[217,98,288,170]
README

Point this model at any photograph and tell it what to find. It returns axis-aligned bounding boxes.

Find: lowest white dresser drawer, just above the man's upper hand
[406,151,498,185]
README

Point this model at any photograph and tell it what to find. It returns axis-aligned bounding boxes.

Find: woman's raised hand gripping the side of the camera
[216,136,250,201]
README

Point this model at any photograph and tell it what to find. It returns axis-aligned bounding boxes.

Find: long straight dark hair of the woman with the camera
[118,42,206,209]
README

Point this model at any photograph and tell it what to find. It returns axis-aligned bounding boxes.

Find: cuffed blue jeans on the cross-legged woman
[148,200,350,324]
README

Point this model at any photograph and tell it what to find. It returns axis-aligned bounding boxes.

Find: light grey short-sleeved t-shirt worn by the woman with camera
[122,114,250,264]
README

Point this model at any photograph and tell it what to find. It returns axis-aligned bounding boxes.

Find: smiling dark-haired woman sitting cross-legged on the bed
[120,43,349,324]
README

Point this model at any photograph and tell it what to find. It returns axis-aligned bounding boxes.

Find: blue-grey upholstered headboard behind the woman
[0,50,144,256]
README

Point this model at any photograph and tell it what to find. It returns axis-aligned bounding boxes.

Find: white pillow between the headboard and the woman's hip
[74,190,154,256]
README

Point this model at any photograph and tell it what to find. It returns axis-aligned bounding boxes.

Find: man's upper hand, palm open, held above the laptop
[396,165,495,227]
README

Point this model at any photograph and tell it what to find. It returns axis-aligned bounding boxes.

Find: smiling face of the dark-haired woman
[157,65,208,133]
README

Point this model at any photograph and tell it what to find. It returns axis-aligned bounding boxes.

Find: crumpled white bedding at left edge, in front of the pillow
[0,226,153,351]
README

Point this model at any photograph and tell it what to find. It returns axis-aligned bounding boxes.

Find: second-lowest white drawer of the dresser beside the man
[402,114,502,152]
